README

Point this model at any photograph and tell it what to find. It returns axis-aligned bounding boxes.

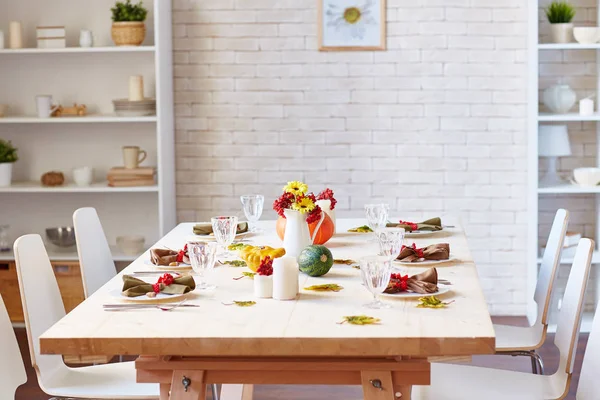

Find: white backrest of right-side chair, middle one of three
[554,239,594,374]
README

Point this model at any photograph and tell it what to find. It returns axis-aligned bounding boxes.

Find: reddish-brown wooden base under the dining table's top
[136,357,430,400]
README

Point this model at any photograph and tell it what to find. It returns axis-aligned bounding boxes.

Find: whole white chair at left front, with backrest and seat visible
[14,235,159,399]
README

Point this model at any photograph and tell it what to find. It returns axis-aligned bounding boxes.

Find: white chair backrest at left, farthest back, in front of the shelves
[73,207,117,298]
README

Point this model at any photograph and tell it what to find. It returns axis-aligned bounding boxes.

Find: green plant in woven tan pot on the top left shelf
[111,0,148,46]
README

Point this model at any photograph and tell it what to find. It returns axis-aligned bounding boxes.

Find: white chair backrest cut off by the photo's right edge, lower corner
[575,298,600,400]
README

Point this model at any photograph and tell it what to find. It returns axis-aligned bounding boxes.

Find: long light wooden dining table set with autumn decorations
[40,219,495,400]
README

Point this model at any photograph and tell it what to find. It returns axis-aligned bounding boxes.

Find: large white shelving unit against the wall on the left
[0,0,176,262]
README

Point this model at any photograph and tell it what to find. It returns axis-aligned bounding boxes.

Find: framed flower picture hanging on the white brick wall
[318,0,386,51]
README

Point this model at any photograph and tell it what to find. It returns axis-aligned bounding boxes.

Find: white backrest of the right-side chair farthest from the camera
[534,208,569,325]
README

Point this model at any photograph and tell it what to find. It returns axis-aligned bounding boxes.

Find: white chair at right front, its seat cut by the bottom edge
[411,239,599,400]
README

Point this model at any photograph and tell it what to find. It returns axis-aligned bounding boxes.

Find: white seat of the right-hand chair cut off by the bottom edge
[412,364,567,400]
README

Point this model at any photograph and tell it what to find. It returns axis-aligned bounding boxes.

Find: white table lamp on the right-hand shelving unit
[538,125,571,186]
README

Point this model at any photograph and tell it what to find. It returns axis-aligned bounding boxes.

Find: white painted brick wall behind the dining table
[174,0,527,315]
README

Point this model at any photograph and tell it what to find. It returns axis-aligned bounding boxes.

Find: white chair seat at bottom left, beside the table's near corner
[42,362,160,399]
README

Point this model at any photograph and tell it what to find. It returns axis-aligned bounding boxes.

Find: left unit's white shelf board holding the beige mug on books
[0,182,158,193]
